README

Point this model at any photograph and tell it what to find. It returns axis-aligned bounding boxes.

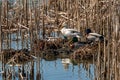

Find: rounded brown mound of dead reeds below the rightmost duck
[71,44,103,59]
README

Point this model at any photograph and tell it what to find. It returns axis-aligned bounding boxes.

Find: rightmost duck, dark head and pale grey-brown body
[85,29,104,43]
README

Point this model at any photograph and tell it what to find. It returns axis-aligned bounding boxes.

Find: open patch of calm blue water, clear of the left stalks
[39,59,94,80]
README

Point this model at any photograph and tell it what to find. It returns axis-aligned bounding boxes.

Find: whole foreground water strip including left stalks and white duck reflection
[0,58,95,80]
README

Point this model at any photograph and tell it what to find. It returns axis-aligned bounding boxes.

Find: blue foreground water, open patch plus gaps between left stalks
[0,58,94,80]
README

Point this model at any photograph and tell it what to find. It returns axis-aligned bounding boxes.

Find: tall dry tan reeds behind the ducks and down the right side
[0,0,120,80]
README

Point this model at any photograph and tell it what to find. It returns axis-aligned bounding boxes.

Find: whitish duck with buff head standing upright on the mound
[60,24,82,39]
